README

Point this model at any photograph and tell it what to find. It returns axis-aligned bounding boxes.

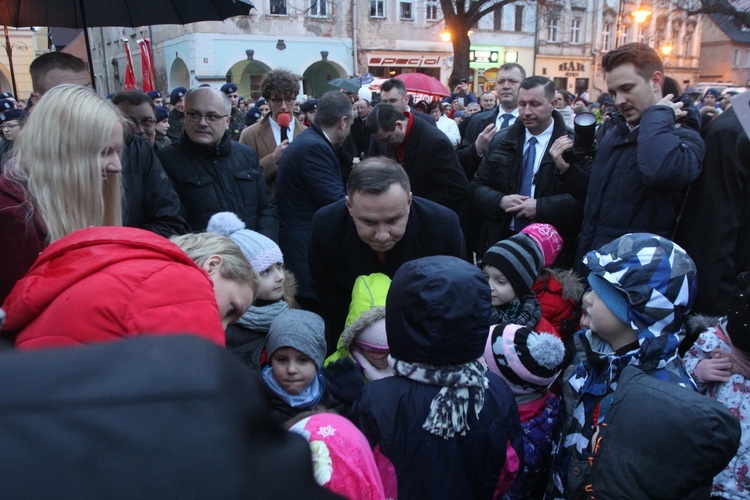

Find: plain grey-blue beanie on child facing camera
[266,309,326,369]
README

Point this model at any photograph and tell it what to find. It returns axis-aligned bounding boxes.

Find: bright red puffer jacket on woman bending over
[3,227,224,349]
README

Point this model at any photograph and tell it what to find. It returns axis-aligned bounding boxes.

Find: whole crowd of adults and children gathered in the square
[0,43,750,499]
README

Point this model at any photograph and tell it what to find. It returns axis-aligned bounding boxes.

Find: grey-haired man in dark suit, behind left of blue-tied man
[457,63,526,180]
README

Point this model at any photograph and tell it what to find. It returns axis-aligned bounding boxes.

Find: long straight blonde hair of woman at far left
[5,84,125,243]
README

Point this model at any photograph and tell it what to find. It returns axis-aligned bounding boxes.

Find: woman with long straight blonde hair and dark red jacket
[0,85,125,303]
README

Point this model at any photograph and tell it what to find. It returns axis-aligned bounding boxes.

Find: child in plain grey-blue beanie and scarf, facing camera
[261,309,327,423]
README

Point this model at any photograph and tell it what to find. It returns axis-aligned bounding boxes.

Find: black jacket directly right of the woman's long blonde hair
[122,134,190,238]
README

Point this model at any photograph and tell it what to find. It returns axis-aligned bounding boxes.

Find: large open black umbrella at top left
[0,0,255,89]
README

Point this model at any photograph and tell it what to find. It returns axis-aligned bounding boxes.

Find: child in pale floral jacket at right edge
[684,273,750,498]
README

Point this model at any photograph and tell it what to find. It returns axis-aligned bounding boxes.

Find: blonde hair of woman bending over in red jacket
[170,233,260,296]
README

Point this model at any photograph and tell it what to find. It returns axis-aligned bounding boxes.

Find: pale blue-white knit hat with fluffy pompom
[206,212,284,273]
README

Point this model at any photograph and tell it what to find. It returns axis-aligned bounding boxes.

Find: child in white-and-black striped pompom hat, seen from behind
[484,325,566,499]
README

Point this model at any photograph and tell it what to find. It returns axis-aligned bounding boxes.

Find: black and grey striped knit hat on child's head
[482,234,544,297]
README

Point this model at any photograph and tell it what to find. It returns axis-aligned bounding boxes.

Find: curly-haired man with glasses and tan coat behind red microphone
[240,69,307,193]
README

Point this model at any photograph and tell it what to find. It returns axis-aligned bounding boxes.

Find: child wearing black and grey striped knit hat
[482,234,557,334]
